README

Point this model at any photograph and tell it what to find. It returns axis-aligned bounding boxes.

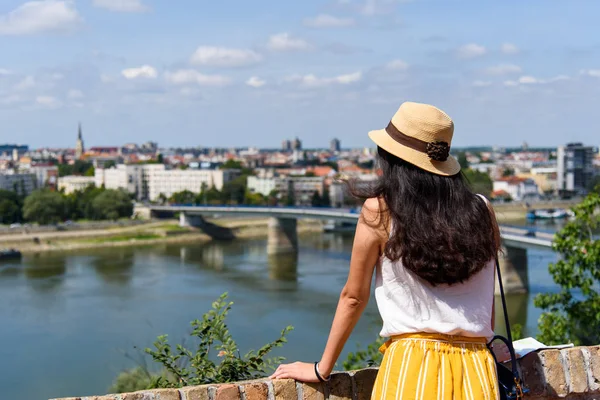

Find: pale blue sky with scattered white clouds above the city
[0,0,600,148]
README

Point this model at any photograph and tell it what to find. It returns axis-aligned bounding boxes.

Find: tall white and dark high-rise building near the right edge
[556,143,598,193]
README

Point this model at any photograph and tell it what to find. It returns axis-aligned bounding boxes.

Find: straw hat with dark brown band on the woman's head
[369,102,460,176]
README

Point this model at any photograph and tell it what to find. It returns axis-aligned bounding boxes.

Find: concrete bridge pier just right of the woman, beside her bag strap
[496,246,529,294]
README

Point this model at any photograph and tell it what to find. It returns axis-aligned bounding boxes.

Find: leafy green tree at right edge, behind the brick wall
[534,193,600,346]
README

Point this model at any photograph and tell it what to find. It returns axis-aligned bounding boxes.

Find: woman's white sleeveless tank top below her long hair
[375,241,495,340]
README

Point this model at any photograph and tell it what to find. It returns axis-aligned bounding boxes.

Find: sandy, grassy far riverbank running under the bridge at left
[0,218,322,254]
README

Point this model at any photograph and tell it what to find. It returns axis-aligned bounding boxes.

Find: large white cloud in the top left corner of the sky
[0,0,82,35]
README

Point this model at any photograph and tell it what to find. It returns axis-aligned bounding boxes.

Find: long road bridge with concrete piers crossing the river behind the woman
[147,205,554,293]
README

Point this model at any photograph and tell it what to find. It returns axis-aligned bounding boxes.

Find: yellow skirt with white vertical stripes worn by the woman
[371,333,499,400]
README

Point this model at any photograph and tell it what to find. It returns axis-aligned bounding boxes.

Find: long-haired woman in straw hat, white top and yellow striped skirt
[272,102,506,400]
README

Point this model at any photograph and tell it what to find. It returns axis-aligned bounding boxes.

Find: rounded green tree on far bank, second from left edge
[23,189,66,225]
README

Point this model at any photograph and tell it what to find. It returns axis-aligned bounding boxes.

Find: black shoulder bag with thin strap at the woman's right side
[488,258,529,400]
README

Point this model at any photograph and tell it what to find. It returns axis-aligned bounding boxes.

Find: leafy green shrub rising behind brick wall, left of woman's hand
[145,293,293,387]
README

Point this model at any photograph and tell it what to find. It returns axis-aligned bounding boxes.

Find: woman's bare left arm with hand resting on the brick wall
[271,199,387,382]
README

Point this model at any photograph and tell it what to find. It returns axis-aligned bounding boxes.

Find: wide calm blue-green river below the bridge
[0,228,556,400]
